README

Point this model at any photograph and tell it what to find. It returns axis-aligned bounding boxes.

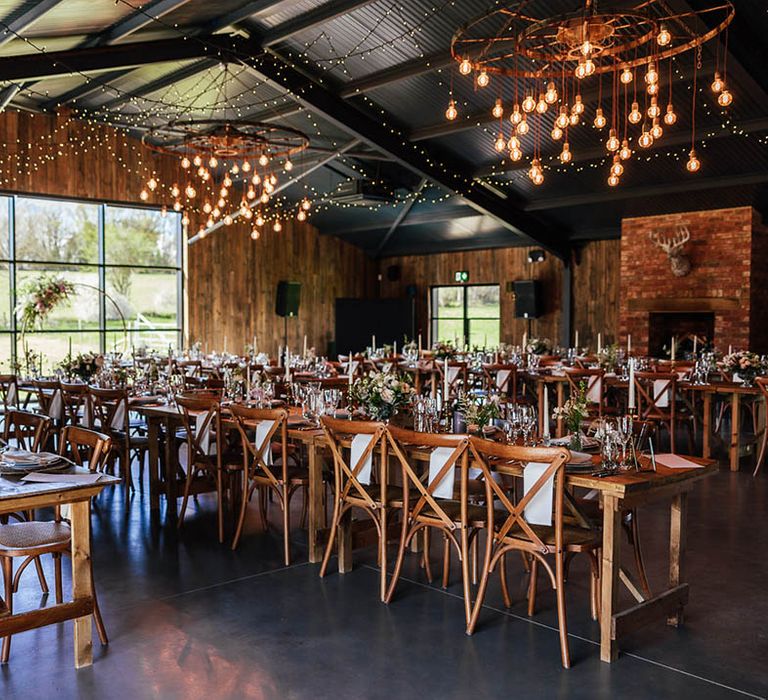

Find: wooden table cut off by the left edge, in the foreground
[0,468,120,668]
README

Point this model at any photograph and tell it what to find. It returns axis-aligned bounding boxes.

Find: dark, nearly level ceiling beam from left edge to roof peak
[0,36,243,80]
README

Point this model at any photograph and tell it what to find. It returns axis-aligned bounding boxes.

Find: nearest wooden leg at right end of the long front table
[600,494,621,663]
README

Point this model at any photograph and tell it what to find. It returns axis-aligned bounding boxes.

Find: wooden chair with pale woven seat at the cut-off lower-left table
[0,426,110,663]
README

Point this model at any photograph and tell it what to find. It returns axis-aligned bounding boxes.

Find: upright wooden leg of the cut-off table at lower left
[71,500,93,668]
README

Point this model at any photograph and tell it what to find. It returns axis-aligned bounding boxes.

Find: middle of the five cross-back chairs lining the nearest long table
[320,416,403,601]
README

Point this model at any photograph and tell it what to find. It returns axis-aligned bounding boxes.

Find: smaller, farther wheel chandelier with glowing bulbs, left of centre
[139,119,311,238]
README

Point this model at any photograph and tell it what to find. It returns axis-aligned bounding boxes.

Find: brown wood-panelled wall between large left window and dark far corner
[188,221,375,354]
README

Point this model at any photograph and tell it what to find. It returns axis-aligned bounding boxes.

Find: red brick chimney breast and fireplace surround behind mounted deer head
[619,207,768,354]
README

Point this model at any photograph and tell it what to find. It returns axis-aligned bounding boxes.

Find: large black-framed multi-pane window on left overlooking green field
[0,195,184,371]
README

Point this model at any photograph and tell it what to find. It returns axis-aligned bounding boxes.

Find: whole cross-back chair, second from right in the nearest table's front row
[385,426,486,624]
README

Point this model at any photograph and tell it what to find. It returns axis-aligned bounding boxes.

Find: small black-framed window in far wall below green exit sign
[430,284,501,347]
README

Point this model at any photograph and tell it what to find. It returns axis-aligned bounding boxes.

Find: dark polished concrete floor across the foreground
[0,460,768,700]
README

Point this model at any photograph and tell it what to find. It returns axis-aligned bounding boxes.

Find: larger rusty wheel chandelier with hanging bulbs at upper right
[445,0,735,186]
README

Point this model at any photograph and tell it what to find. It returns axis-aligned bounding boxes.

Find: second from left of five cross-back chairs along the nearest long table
[230,404,309,566]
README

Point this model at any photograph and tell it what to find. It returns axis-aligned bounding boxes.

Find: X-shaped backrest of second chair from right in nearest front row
[387,425,469,529]
